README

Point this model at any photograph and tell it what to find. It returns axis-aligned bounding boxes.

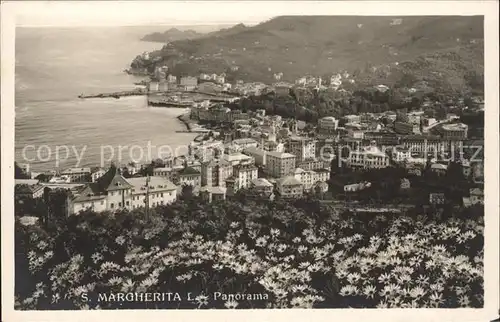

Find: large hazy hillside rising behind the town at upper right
[133,16,484,92]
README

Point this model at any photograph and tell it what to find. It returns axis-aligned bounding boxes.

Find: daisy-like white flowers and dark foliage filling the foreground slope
[16,196,484,309]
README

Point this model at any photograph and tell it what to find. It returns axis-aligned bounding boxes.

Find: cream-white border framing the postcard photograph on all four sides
[1,0,500,322]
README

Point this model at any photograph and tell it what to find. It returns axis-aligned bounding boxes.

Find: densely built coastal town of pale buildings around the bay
[16,59,484,221]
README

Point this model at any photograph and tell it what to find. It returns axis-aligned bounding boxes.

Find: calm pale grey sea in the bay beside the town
[15,27,195,172]
